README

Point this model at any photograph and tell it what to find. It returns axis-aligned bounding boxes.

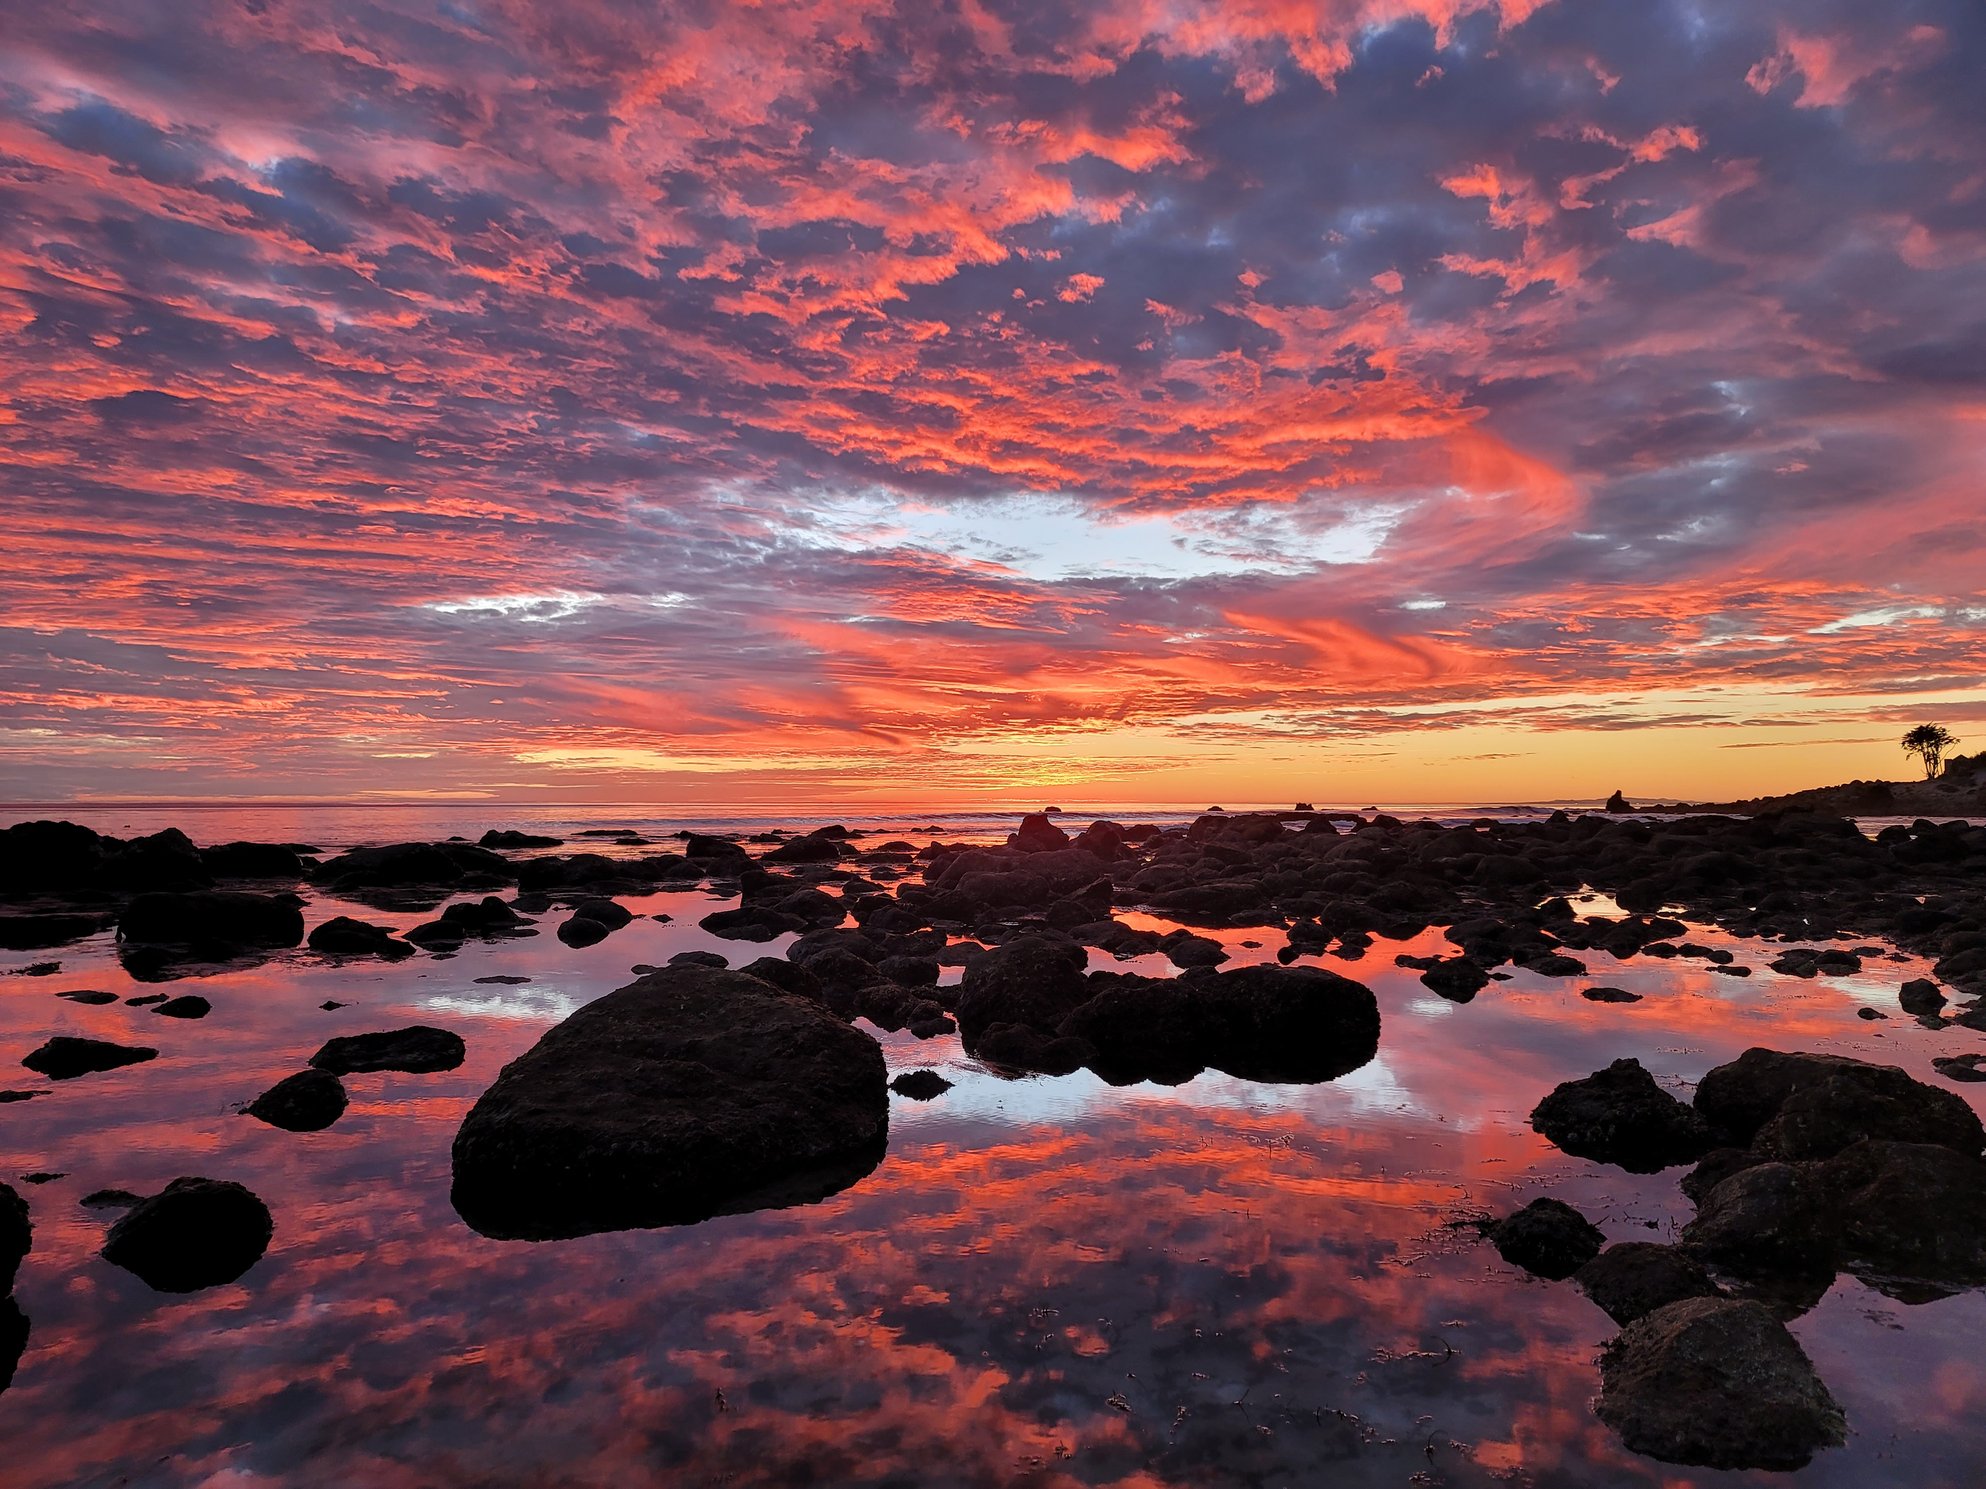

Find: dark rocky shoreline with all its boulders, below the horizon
[0,788,1986,1467]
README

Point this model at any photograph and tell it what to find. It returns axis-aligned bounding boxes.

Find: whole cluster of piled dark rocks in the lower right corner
[1482,1048,1986,1469]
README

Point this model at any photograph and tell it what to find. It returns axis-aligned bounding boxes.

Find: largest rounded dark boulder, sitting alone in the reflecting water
[453,967,890,1241]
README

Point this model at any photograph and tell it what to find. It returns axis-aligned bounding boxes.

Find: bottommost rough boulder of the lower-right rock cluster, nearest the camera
[1599,1298,1847,1469]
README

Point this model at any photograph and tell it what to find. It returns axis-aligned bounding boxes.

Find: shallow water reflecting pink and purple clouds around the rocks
[0,808,1986,1489]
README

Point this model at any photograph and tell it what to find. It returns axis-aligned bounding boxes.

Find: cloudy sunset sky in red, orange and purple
[0,0,1986,804]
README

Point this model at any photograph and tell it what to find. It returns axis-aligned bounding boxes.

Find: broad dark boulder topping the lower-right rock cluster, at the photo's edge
[1696,1048,1986,1159]
